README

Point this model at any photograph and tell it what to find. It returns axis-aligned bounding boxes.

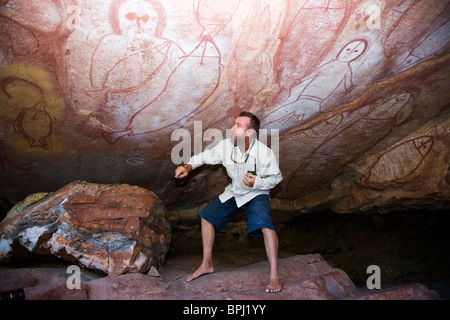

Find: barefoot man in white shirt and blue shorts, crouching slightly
[175,112,283,292]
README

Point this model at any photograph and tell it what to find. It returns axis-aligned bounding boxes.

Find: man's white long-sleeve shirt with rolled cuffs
[188,138,283,207]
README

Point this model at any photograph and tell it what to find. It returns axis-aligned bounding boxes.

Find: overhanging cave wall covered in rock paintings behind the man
[0,0,450,213]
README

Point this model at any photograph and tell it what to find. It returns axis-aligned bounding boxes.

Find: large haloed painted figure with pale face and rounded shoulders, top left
[88,0,184,132]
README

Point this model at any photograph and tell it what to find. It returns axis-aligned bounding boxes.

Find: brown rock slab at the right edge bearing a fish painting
[332,116,450,213]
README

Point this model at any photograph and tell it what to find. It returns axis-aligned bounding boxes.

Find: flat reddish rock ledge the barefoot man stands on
[0,254,439,300]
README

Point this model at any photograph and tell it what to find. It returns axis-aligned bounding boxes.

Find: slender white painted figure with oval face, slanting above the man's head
[261,39,368,129]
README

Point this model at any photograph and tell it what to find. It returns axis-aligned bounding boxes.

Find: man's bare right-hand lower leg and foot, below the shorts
[261,227,283,292]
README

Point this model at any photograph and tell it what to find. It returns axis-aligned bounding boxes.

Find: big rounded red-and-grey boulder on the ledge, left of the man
[0,181,171,274]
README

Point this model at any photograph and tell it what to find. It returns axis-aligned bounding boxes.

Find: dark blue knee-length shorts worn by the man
[198,194,275,237]
